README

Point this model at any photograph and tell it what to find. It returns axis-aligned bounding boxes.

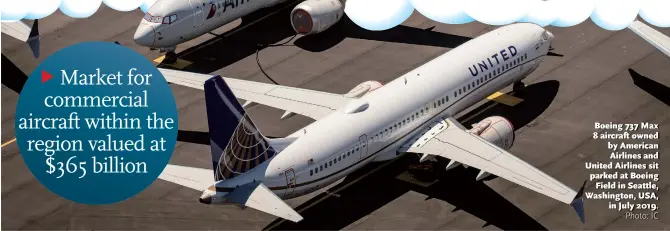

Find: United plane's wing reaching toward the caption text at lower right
[399,118,584,222]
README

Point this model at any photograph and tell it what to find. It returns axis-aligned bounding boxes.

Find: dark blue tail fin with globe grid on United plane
[204,75,277,181]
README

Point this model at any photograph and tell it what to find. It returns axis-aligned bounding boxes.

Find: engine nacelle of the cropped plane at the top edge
[291,0,344,35]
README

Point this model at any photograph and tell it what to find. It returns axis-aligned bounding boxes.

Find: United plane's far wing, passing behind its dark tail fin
[159,68,351,120]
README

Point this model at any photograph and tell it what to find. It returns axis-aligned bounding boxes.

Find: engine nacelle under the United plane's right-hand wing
[470,116,514,150]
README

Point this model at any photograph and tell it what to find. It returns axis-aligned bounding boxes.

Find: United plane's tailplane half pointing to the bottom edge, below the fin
[226,182,303,222]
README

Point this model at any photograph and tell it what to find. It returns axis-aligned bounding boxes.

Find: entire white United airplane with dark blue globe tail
[160,23,584,222]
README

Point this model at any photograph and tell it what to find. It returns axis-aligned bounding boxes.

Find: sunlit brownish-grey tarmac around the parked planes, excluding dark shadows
[2,4,670,230]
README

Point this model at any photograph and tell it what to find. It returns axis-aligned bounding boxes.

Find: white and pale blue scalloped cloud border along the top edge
[0,0,670,30]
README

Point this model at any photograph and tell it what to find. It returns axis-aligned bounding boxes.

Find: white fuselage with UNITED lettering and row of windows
[206,23,553,202]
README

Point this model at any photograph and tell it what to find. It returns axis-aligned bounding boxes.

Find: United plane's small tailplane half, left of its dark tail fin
[158,164,213,191]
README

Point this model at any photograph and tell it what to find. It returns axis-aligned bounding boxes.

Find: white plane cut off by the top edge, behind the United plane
[134,0,344,63]
